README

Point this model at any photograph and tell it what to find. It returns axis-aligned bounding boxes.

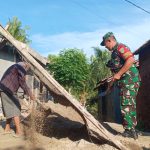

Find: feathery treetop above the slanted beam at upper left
[7,17,31,44]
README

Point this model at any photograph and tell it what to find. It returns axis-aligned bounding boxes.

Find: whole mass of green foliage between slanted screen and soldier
[48,47,111,118]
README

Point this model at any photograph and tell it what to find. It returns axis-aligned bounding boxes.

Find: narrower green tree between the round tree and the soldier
[86,47,111,117]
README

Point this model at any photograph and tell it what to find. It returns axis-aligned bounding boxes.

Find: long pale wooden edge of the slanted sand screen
[0,26,126,150]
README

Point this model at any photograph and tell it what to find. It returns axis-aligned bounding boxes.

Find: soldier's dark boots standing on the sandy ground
[122,129,138,140]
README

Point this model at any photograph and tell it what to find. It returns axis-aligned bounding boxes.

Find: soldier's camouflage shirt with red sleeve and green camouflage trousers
[109,43,140,129]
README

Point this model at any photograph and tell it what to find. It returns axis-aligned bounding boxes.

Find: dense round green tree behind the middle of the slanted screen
[48,49,90,101]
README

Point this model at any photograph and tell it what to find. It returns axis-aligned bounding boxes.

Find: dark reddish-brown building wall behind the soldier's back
[137,47,150,130]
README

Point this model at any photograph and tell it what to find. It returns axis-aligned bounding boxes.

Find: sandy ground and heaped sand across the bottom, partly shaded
[0,102,150,150]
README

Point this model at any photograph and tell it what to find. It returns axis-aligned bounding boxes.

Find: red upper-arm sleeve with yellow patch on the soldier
[118,44,133,60]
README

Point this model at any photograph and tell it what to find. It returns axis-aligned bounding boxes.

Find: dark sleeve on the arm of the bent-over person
[18,70,32,96]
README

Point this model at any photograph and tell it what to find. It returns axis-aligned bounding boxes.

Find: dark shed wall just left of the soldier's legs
[98,84,122,123]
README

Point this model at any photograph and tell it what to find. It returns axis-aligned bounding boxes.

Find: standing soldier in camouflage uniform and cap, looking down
[101,32,140,139]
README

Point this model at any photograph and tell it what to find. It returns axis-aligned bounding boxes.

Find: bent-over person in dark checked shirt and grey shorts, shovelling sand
[0,62,35,137]
